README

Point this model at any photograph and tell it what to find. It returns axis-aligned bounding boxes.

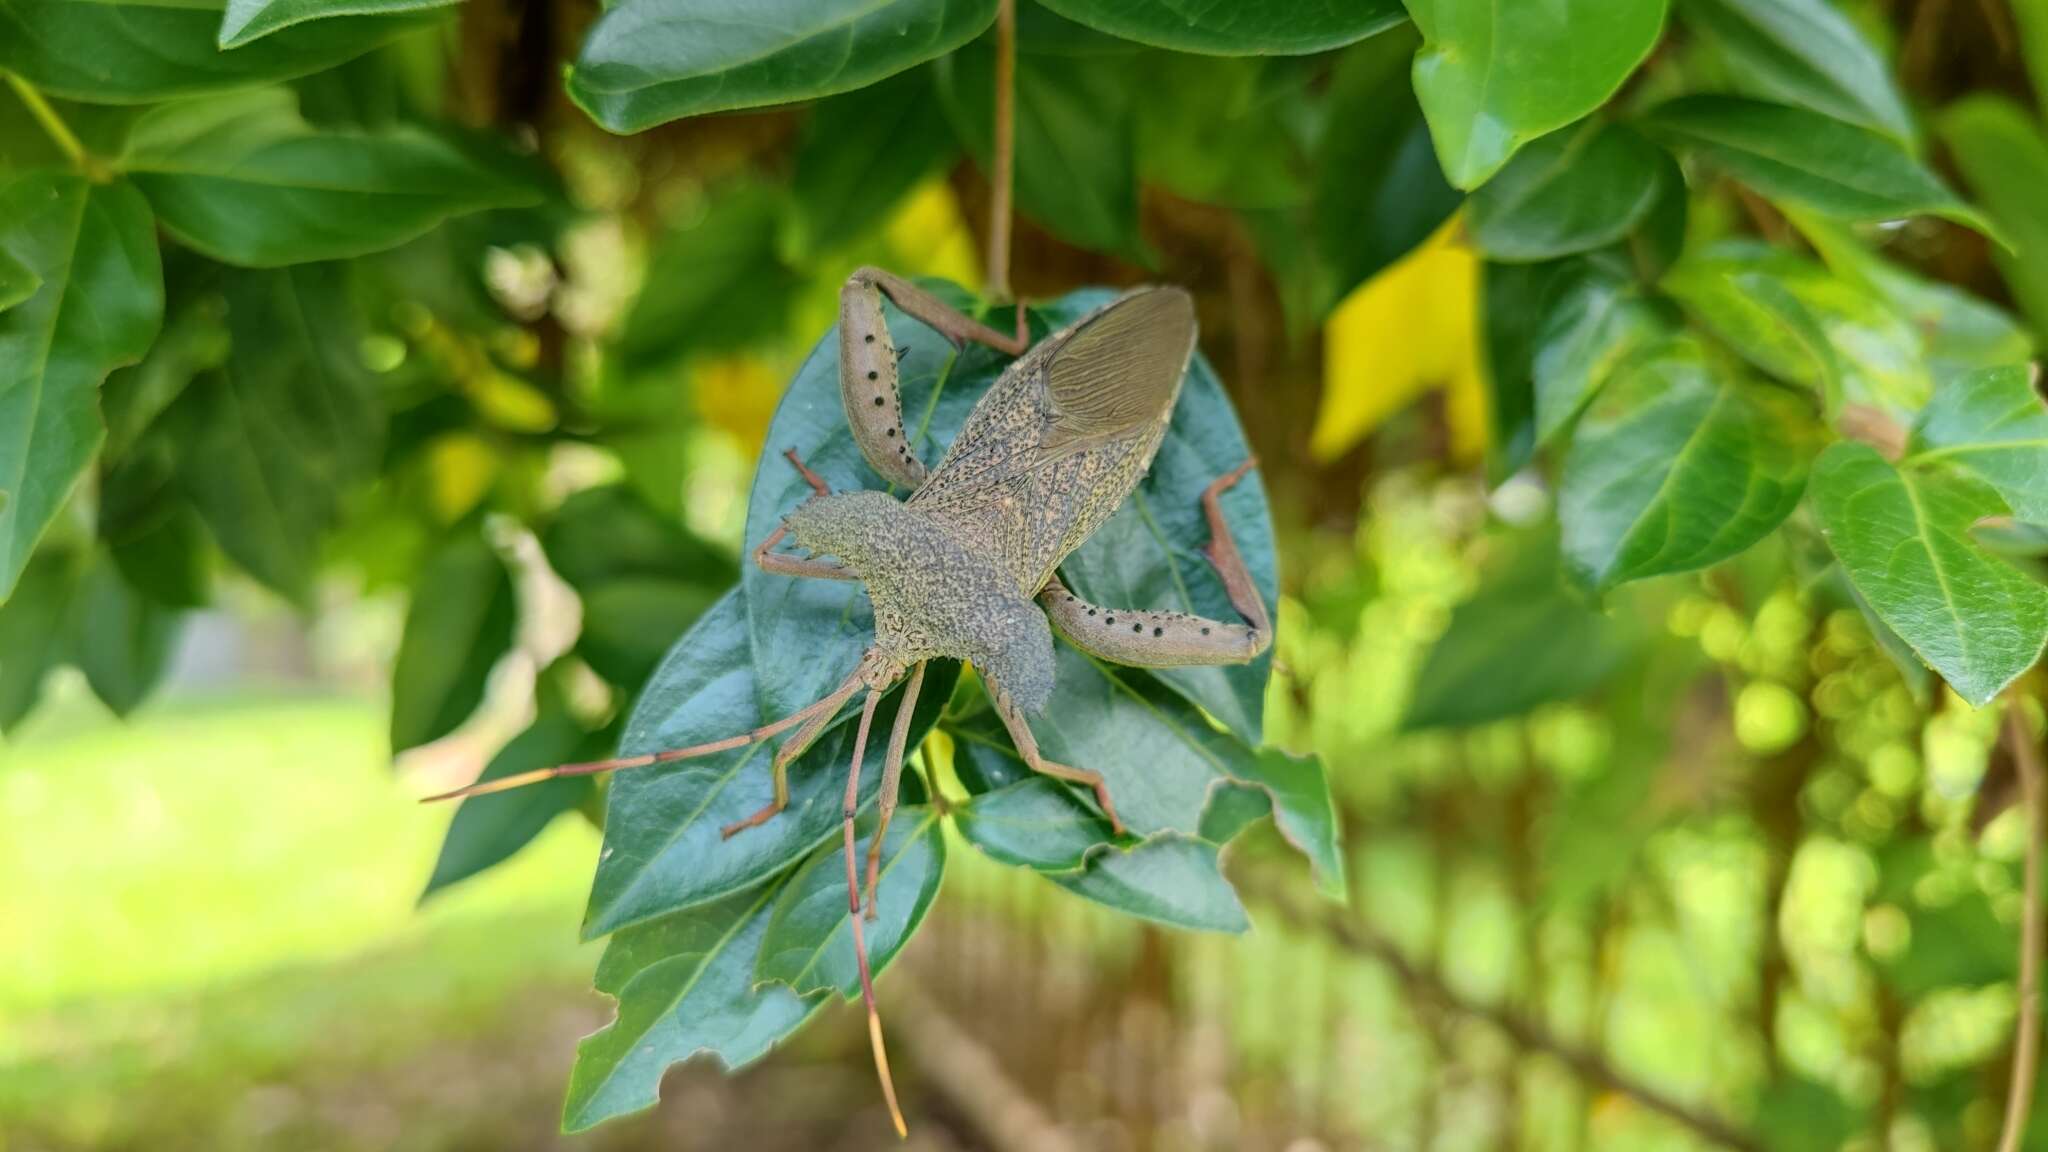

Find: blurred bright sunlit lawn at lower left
[0,693,598,1150]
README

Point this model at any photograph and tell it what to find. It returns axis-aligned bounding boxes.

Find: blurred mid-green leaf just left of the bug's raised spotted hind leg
[618,182,801,377]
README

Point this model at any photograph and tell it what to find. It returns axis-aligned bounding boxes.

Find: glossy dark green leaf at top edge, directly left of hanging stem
[569,0,995,131]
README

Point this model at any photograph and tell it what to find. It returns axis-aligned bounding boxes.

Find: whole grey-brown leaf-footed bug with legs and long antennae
[430,269,1272,1134]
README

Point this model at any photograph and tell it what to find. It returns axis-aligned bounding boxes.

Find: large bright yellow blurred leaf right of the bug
[1309,217,1489,463]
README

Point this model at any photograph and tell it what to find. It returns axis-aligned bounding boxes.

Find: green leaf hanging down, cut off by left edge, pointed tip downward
[0,174,164,601]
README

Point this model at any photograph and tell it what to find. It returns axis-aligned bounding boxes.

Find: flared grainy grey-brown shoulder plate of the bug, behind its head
[786,492,1053,711]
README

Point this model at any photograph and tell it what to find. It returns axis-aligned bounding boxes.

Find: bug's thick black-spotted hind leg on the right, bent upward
[1038,459,1274,668]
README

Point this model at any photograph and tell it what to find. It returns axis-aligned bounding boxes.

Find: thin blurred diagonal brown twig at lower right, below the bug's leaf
[1251,883,1763,1152]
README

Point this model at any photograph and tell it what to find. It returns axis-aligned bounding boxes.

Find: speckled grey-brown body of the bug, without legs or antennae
[784,289,1194,711]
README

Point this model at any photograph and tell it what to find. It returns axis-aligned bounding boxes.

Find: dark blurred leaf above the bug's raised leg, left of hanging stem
[782,70,954,260]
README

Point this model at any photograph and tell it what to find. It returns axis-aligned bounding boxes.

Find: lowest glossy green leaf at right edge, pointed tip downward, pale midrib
[1812,441,2048,707]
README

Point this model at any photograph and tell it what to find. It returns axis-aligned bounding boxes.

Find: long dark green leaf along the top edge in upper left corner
[0,0,440,105]
